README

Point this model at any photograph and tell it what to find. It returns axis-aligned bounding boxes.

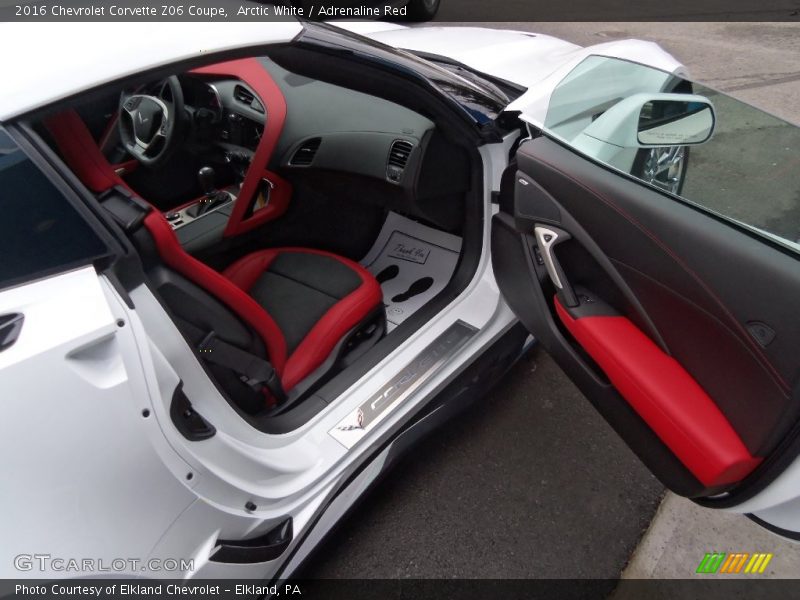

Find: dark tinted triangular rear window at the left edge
[0,128,107,288]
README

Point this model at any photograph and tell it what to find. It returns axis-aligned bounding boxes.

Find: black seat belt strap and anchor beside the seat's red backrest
[177,319,287,406]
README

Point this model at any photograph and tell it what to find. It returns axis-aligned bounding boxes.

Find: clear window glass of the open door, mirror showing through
[544,56,800,251]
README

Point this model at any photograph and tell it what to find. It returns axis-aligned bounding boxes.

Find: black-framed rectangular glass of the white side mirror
[637,96,714,146]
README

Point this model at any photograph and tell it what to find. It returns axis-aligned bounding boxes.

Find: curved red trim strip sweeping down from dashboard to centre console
[192,58,292,236]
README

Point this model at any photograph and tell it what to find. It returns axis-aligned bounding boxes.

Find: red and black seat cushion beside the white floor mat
[223,248,383,390]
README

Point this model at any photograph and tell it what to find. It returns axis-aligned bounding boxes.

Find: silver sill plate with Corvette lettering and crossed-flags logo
[328,321,477,448]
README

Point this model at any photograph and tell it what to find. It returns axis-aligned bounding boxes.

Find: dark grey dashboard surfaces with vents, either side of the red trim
[181,64,434,186]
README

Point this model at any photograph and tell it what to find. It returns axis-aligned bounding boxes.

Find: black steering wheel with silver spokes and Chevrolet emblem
[117,75,186,167]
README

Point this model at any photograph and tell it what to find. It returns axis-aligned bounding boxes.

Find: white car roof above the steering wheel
[0,22,303,121]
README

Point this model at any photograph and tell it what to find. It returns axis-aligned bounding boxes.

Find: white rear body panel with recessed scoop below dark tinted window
[0,267,195,578]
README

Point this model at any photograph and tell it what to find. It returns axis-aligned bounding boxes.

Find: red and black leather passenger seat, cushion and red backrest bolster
[47,111,383,391]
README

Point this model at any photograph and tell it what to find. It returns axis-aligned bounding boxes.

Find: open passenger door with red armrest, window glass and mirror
[492,56,800,539]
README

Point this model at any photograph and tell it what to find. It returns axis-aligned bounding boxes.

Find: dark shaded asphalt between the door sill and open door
[298,350,663,579]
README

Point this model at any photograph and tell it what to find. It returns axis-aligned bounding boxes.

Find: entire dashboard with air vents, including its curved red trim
[166,57,460,243]
